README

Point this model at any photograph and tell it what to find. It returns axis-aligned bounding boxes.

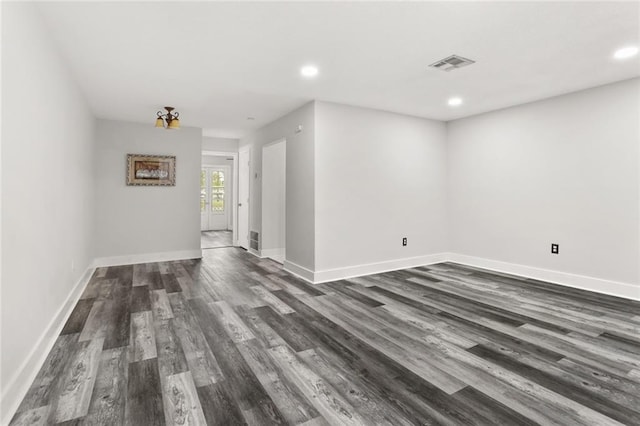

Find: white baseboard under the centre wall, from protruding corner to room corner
[312,253,447,284]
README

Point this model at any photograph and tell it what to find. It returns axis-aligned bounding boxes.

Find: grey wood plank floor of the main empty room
[11,248,640,426]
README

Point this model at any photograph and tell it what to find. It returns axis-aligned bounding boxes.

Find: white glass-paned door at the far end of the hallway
[200,166,231,231]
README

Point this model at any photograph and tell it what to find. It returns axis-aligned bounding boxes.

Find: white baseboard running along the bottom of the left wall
[0,266,95,425]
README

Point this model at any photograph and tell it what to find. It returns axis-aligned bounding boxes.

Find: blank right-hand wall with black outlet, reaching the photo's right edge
[448,79,640,297]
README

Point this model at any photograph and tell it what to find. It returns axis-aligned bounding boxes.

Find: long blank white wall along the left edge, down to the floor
[0,2,94,418]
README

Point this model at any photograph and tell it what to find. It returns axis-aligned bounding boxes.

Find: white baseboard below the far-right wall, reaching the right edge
[447,253,640,300]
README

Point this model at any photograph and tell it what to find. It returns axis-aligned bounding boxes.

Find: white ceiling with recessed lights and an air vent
[39,1,640,137]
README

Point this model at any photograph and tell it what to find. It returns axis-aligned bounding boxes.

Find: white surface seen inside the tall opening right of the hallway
[260,141,287,256]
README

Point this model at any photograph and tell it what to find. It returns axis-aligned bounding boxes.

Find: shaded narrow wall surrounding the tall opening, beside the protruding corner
[240,102,315,272]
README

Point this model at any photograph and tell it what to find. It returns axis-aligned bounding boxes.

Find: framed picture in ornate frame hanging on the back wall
[127,154,176,186]
